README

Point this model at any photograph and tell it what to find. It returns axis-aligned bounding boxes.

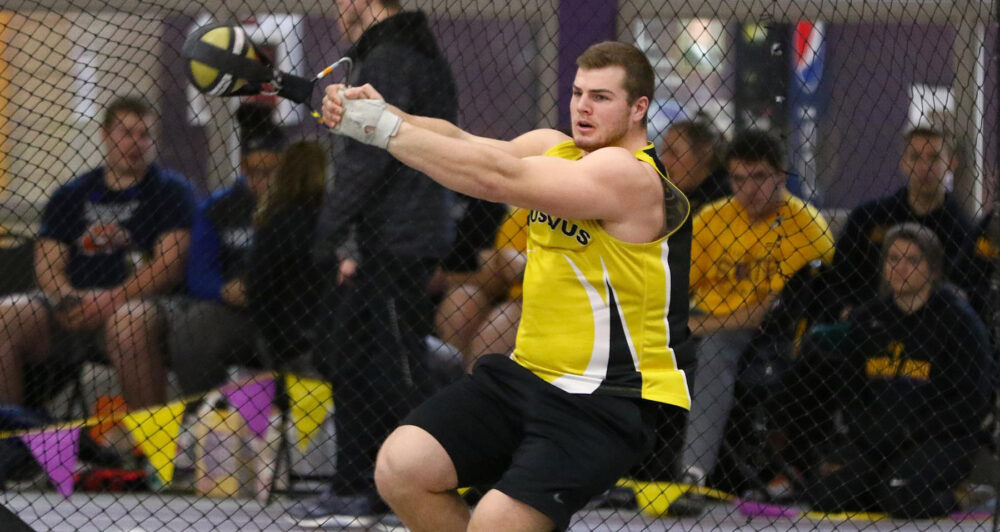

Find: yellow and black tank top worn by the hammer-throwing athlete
[512,141,691,408]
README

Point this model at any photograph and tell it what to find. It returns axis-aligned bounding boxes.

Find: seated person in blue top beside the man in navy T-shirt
[107,103,285,408]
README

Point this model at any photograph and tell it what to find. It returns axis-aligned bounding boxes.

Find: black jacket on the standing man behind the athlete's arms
[314,12,458,264]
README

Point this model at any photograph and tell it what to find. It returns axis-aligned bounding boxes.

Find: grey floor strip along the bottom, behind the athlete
[0,492,993,532]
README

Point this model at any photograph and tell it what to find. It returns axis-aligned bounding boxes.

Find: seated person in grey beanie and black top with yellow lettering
[803,223,992,519]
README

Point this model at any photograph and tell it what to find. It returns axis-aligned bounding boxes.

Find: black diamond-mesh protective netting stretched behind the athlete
[0,0,1000,530]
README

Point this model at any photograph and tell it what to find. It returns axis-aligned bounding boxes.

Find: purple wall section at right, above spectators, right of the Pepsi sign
[819,24,997,212]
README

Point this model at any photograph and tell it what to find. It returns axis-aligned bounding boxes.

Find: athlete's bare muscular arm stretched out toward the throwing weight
[323,87,662,234]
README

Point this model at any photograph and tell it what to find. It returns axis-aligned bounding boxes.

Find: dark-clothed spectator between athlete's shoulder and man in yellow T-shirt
[660,112,733,216]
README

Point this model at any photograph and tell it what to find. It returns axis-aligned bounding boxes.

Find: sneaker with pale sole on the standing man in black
[287,491,389,528]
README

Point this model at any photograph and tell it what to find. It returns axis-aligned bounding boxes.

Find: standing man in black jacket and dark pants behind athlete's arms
[289,0,458,526]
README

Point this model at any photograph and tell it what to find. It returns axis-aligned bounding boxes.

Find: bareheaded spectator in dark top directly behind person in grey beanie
[833,127,973,305]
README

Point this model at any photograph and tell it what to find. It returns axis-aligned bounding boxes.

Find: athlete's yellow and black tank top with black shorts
[403,141,691,529]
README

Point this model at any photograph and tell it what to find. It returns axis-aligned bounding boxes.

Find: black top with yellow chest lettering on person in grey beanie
[833,288,993,452]
